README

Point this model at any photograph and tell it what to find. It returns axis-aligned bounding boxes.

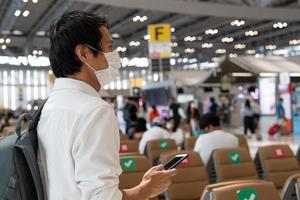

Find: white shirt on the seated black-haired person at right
[194,130,239,164]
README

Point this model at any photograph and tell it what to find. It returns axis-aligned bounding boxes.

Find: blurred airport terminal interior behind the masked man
[0,0,300,200]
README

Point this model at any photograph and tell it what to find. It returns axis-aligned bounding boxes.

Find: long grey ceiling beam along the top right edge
[77,0,300,21]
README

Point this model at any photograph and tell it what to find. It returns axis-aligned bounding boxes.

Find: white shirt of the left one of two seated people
[139,126,171,154]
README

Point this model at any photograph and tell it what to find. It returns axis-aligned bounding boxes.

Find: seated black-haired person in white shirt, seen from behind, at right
[194,113,239,164]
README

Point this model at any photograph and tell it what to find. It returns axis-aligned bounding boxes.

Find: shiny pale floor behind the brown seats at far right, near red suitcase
[231,116,300,158]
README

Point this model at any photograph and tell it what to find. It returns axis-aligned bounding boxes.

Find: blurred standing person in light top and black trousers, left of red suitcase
[242,99,255,138]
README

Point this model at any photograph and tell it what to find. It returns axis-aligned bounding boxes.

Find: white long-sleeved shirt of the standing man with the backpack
[38,78,122,200]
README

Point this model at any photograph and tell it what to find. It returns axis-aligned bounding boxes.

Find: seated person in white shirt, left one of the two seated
[139,117,171,154]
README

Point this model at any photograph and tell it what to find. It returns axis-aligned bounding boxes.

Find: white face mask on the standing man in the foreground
[85,45,121,88]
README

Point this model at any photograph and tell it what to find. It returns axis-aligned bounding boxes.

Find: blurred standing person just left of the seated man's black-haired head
[186,101,200,136]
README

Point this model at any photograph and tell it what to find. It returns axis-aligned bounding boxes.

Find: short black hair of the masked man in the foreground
[49,11,107,78]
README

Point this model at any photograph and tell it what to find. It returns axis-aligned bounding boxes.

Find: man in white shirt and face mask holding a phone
[37,11,176,200]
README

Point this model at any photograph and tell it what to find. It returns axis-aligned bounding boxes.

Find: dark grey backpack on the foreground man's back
[0,106,44,200]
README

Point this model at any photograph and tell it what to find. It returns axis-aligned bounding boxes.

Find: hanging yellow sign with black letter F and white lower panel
[148,24,172,59]
